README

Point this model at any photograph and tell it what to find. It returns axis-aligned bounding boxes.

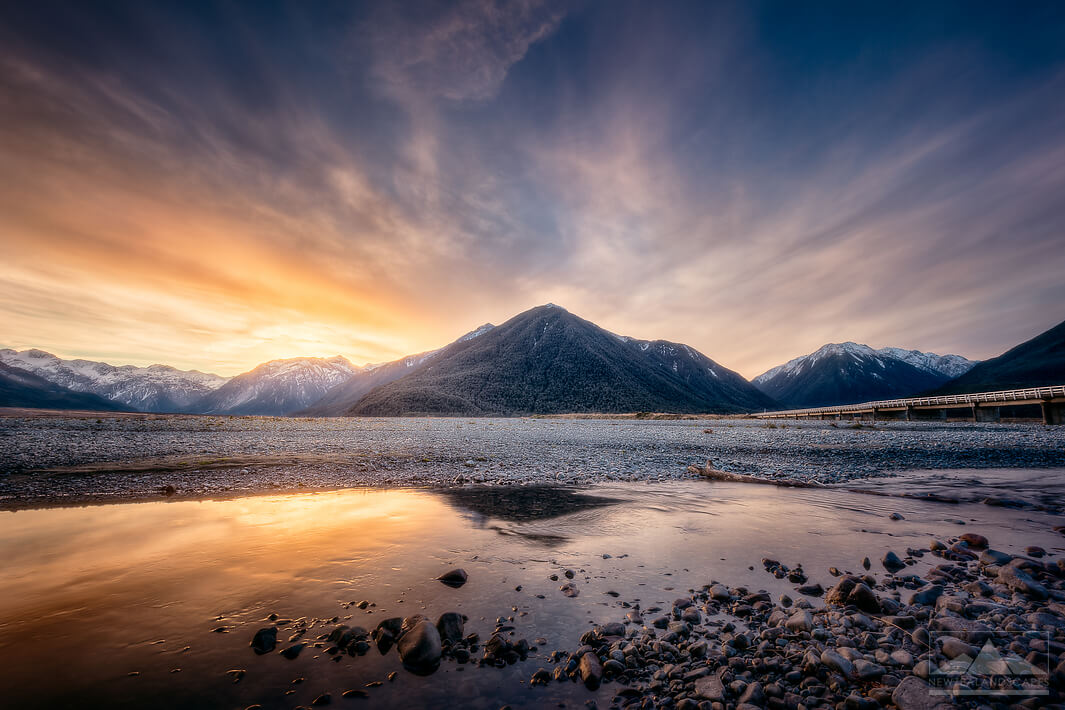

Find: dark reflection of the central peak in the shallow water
[438,485,621,547]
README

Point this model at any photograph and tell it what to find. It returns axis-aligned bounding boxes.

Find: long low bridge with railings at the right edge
[752,384,1065,424]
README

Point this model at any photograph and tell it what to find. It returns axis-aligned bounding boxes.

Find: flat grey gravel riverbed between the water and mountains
[0,415,1065,506]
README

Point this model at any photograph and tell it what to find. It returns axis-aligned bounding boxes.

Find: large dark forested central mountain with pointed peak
[346,304,774,416]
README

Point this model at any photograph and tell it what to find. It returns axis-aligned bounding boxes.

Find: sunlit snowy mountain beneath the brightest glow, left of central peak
[192,356,359,416]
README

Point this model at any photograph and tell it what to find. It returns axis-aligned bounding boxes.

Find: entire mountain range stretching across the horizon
[0,304,1065,416]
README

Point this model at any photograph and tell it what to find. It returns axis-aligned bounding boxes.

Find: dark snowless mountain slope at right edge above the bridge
[935,321,1065,394]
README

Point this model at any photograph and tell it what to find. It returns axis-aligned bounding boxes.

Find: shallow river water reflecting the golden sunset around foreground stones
[0,469,1065,708]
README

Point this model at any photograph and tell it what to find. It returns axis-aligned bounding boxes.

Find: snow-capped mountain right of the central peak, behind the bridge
[752,343,972,409]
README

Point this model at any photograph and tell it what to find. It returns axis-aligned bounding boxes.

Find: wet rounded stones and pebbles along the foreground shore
[241,528,1065,710]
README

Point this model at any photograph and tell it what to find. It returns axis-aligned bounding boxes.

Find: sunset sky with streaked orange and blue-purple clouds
[0,0,1065,378]
